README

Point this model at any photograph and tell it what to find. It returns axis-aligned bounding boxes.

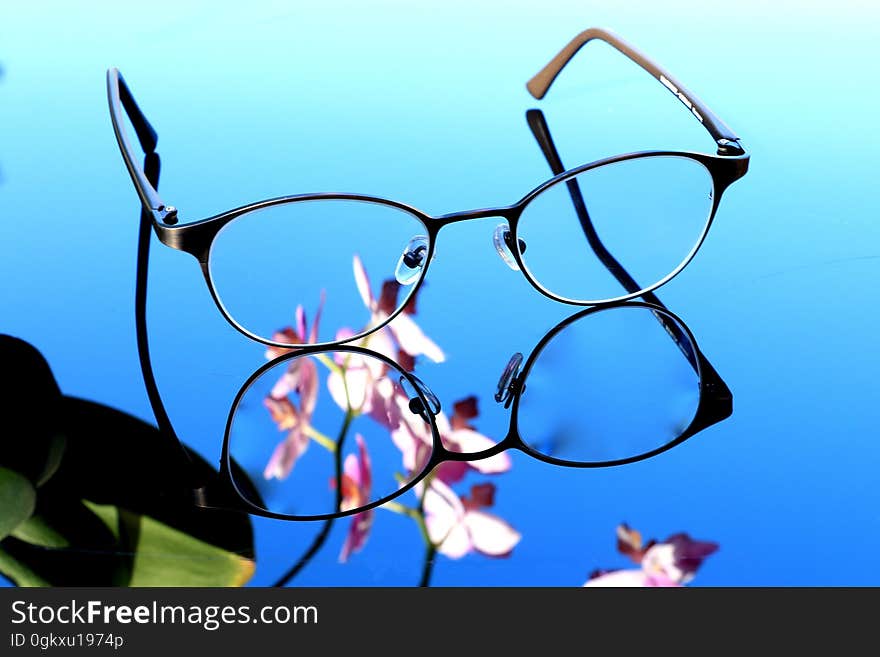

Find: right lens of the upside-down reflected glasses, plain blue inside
[517,306,700,463]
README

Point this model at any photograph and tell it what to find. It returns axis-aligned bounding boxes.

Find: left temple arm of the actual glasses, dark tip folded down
[107,68,177,224]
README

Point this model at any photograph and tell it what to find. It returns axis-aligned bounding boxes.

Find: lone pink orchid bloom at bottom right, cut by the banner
[584,524,718,586]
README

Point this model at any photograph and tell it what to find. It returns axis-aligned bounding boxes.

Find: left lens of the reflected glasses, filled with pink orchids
[229,350,434,517]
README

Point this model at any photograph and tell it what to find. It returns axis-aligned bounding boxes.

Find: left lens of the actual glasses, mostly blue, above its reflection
[208,199,427,344]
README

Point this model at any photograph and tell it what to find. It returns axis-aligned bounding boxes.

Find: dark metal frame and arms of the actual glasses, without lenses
[107,28,749,347]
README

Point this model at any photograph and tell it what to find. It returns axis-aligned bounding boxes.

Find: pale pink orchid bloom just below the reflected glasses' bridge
[423,479,521,559]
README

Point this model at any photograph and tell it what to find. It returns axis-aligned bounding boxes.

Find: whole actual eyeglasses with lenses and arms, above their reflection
[107,29,749,347]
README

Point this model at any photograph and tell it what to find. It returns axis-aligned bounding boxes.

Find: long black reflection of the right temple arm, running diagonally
[526,109,733,428]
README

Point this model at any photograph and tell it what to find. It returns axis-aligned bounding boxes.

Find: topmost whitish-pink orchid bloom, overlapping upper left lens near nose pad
[353,254,446,369]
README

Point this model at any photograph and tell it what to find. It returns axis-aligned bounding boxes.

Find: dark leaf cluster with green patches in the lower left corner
[0,336,254,586]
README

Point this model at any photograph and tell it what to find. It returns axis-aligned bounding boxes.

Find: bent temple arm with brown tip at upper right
[526,27,745,155]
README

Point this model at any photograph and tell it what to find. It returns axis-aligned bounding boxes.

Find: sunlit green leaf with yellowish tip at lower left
[86,501,254,586]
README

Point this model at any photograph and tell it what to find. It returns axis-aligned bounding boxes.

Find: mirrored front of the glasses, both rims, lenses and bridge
[221,302,732,520]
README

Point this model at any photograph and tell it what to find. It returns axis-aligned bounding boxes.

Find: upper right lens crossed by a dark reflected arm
[517,156,714,303]
